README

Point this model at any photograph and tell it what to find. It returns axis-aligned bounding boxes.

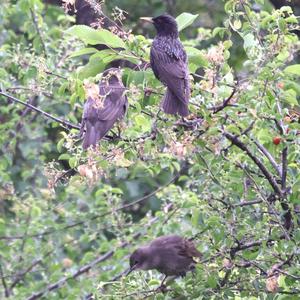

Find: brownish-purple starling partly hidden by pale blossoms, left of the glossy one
[81,68,128,149]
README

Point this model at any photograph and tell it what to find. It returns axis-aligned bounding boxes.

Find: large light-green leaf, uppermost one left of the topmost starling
[66,25,126,48]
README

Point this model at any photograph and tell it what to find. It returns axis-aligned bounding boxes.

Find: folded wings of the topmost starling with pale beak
[150,47,190,103]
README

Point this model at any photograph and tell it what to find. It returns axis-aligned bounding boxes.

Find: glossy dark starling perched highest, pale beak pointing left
[141,14,190,117]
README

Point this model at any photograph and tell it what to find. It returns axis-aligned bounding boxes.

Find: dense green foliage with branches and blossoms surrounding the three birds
[0,0,300,299]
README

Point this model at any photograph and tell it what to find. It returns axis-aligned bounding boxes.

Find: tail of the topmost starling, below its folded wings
[162,88,189,117]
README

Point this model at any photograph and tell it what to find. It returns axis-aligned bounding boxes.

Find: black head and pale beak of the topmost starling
[141,14,178,37]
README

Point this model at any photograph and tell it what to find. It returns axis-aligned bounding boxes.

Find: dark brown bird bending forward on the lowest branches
[129,235,202,276]
